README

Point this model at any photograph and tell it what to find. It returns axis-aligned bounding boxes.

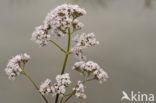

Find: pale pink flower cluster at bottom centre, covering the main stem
[51,73,71,95]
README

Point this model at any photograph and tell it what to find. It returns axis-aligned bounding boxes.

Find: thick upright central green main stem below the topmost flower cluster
[55,28,71,103]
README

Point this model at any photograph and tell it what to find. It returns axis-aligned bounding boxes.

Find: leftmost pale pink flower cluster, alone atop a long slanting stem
[5,53,30,80]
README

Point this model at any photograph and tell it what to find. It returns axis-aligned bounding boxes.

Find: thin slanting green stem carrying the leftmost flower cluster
[21,68,49,103]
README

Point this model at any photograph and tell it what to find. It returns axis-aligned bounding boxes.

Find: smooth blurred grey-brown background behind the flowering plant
[0,0,156,103]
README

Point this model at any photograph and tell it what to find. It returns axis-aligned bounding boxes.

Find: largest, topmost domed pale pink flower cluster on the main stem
[44,4,86,37]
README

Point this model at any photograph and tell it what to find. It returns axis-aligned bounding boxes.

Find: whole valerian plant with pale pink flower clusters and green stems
[5,4,108,103]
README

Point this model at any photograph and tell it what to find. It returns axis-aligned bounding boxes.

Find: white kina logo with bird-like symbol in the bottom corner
[121,91,154,102]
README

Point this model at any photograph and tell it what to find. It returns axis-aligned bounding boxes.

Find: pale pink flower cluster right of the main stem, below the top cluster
[71,33,99,60]
